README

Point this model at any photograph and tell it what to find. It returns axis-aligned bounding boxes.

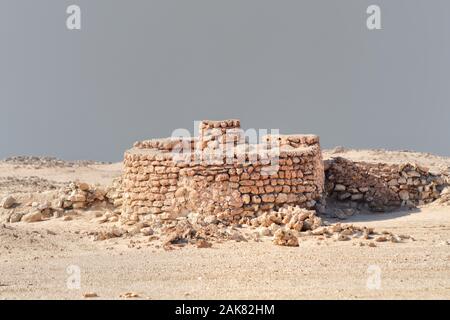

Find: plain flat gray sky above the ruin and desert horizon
[0,0,450,161]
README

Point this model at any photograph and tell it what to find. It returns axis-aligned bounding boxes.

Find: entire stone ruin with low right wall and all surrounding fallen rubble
[0,120,450,249]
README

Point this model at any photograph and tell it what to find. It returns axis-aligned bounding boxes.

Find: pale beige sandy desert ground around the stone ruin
[0,151,450,299]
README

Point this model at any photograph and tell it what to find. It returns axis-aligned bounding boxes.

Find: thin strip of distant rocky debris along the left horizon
[3,156,109,168]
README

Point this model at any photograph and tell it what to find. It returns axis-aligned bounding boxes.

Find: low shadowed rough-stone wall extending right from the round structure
[325,157,445,212]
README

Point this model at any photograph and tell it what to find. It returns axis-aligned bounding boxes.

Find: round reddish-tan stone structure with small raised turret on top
[121,120,324,224]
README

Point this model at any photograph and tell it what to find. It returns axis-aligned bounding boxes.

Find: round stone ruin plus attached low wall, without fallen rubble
[120,120,448,225]
